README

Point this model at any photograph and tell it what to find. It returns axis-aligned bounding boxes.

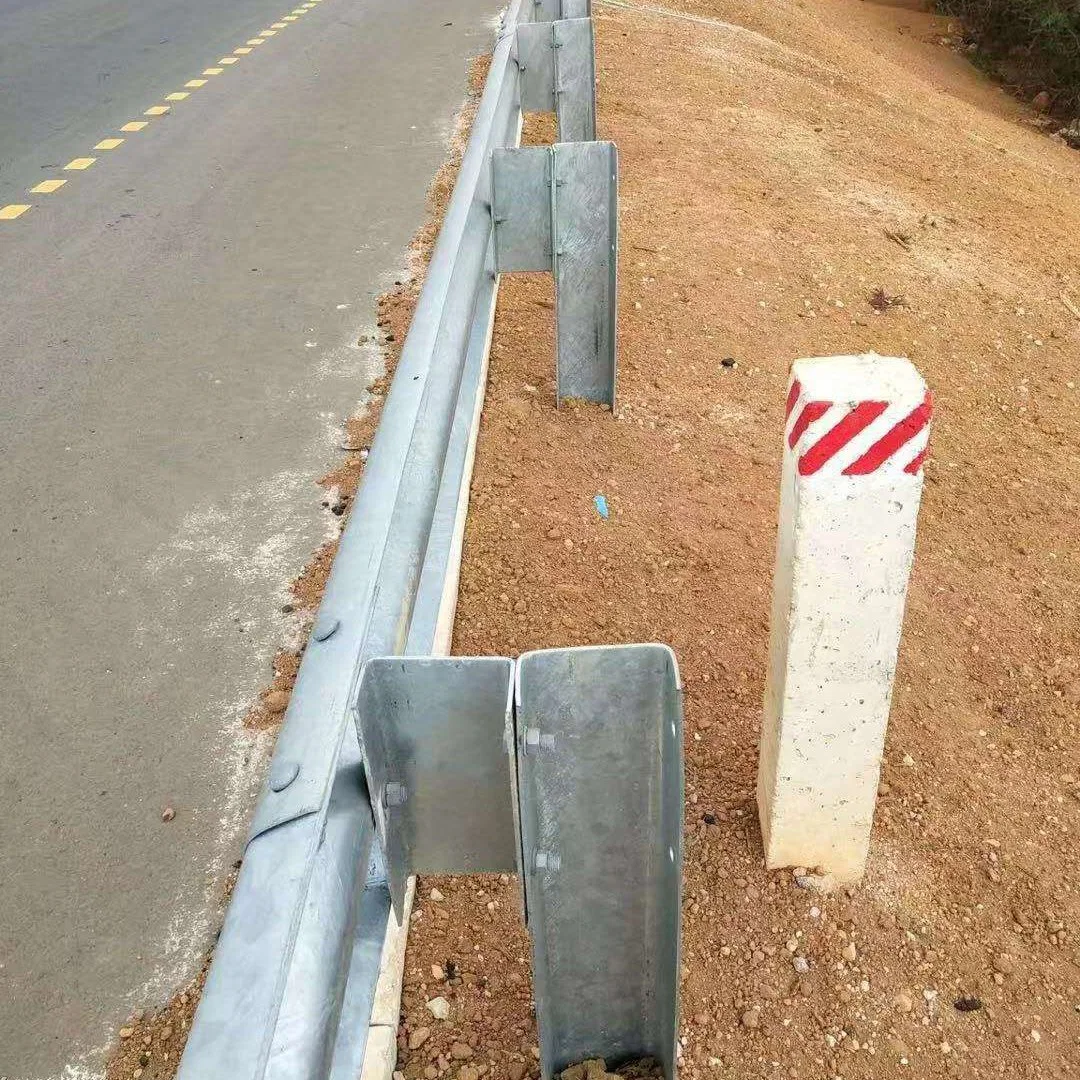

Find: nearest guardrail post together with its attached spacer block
[356,645,683,1080]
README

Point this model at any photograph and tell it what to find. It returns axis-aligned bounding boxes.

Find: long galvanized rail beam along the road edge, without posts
[178,0,529,1080]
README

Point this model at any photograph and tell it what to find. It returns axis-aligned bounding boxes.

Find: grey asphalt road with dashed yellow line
[0,0,499,1080]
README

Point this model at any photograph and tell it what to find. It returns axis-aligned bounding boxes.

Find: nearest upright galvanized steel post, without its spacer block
[515,645,683,1080]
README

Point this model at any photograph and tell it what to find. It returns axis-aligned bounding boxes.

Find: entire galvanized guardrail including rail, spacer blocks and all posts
[178,0,683,1080]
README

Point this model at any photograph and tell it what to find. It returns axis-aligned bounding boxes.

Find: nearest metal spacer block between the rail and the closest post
[356,657,521,920]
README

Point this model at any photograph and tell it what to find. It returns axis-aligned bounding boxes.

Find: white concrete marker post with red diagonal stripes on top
[757,354,931,881]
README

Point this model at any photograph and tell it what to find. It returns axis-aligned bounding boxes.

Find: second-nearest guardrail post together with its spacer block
[491,143,619,407]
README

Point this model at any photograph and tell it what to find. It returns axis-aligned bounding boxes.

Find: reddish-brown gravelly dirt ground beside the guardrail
[397,0,1080,1080]
